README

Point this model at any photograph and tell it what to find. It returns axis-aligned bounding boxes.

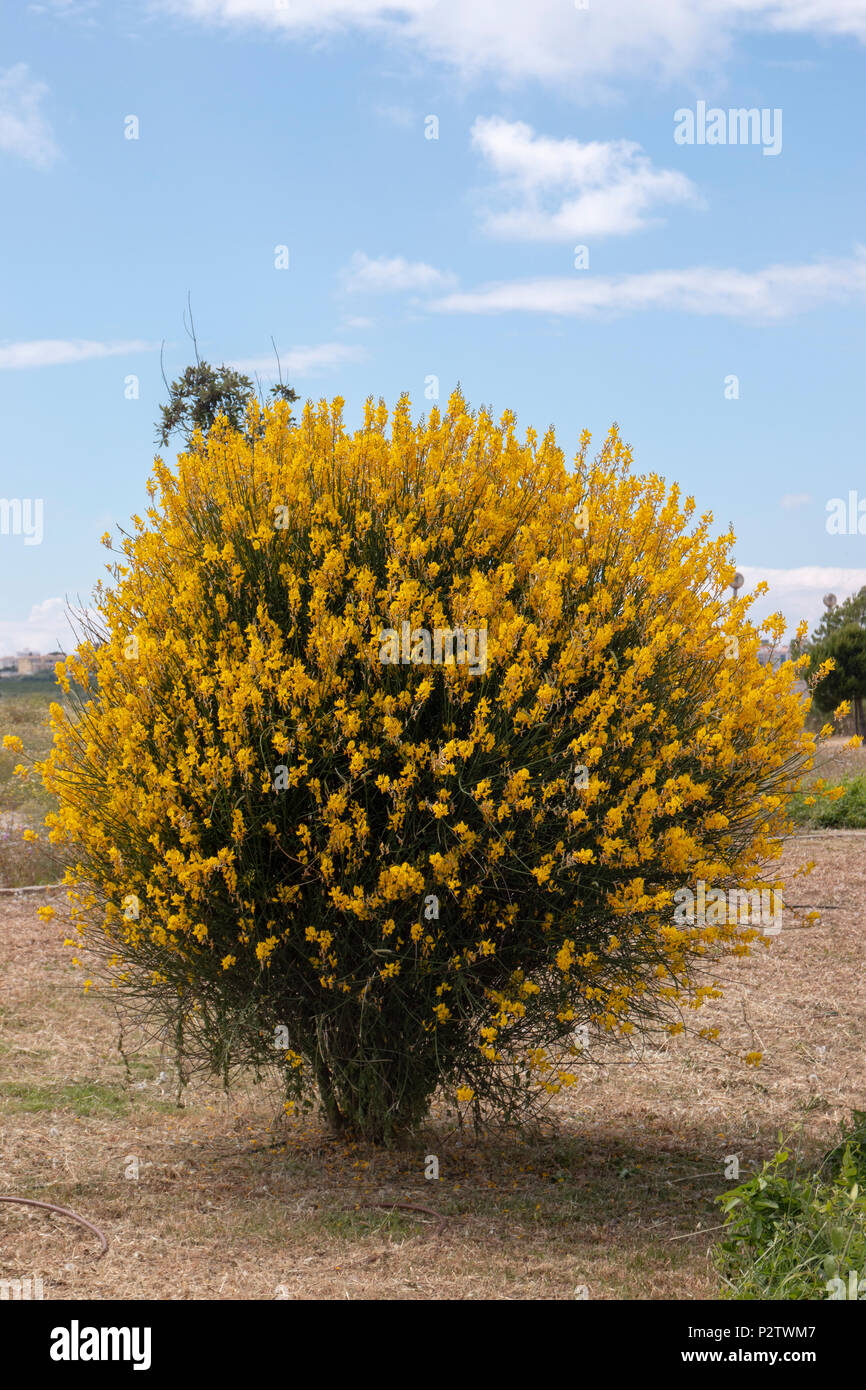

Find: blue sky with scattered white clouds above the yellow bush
[0,0,866,655]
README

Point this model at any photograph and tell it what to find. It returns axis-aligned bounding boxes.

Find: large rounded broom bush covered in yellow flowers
[25,393,828,1141]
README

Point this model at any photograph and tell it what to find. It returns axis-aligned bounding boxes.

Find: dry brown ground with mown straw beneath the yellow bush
[0,831,866,1300]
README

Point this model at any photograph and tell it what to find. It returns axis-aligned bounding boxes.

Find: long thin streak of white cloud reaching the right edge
[428,252,866,321]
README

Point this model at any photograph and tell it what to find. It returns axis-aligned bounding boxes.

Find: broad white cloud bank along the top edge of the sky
[150,0,866,88]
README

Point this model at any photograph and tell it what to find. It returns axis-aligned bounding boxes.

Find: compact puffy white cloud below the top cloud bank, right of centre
[471,117,698,240]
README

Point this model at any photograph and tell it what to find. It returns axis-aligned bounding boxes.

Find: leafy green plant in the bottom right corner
[714,1111,866,1300]
